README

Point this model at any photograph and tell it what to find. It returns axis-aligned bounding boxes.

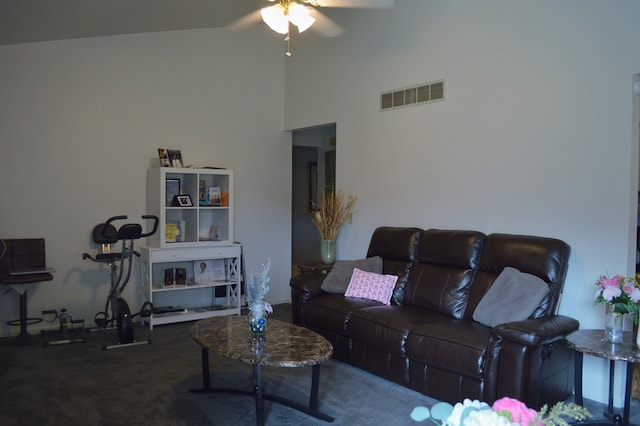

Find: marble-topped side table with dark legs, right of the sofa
[564,329,640,426]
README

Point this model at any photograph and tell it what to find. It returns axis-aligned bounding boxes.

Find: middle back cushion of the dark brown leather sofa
[402,229,486,319]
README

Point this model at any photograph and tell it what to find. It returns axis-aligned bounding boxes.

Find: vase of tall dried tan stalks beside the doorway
[311,191,357,264]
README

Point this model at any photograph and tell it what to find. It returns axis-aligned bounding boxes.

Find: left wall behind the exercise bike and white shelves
[0,27,291,335]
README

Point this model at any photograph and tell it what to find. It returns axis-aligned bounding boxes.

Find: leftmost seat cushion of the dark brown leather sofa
[304,293,381,336]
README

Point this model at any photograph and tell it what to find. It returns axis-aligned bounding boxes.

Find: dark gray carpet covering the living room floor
[0,305,640,426]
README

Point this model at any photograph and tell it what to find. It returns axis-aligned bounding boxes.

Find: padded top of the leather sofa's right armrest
[493,315,580,346]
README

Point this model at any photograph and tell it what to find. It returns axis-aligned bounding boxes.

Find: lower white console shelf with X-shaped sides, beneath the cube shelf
[140,244,242,330]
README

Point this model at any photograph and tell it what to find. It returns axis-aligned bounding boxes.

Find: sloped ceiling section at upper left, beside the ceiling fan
[0,0,264,44]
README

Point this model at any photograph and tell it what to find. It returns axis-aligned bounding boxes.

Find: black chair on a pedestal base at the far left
[0,238,53,346]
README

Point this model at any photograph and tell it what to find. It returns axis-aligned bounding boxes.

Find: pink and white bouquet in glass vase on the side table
[595,275,640,324]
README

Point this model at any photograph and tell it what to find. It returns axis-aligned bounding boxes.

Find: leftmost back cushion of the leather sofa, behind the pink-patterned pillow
[367,226,423,305]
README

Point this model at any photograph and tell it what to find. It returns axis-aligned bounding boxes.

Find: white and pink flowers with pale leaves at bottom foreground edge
[411,397,592,426]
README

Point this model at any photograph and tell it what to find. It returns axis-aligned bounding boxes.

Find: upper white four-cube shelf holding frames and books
[147,167,233,248]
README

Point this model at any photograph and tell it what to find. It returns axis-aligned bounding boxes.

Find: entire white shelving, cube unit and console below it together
[140,167,243,329]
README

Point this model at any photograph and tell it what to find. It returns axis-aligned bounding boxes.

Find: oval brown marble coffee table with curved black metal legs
[191,316,334,425]
